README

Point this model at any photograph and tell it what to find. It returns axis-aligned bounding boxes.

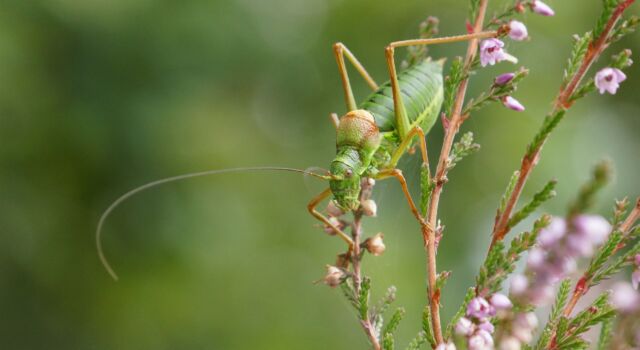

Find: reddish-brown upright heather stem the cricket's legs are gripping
[422,0,489,344]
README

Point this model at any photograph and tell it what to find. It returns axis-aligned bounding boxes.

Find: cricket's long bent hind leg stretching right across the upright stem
[385,31,498,140]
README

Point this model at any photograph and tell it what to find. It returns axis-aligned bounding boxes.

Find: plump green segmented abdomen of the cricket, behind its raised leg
[360,60,443,133]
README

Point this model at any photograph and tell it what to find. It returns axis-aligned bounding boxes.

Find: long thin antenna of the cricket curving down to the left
[96,166,332,281]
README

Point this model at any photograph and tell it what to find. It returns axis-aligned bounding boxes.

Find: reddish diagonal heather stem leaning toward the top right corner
[491,0,635,247]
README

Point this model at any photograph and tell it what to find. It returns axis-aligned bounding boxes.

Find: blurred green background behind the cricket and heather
[0,0,640,349]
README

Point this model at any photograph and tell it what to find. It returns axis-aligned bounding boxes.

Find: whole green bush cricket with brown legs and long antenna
[96,31,498,280]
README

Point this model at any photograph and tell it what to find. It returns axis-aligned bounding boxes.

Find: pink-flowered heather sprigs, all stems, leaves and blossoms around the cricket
[316,0,640,350]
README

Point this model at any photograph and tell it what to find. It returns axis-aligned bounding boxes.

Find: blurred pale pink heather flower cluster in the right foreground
[511,215,611,306]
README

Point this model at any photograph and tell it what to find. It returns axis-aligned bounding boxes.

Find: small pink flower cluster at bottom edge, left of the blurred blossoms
[456,293,513,350]
